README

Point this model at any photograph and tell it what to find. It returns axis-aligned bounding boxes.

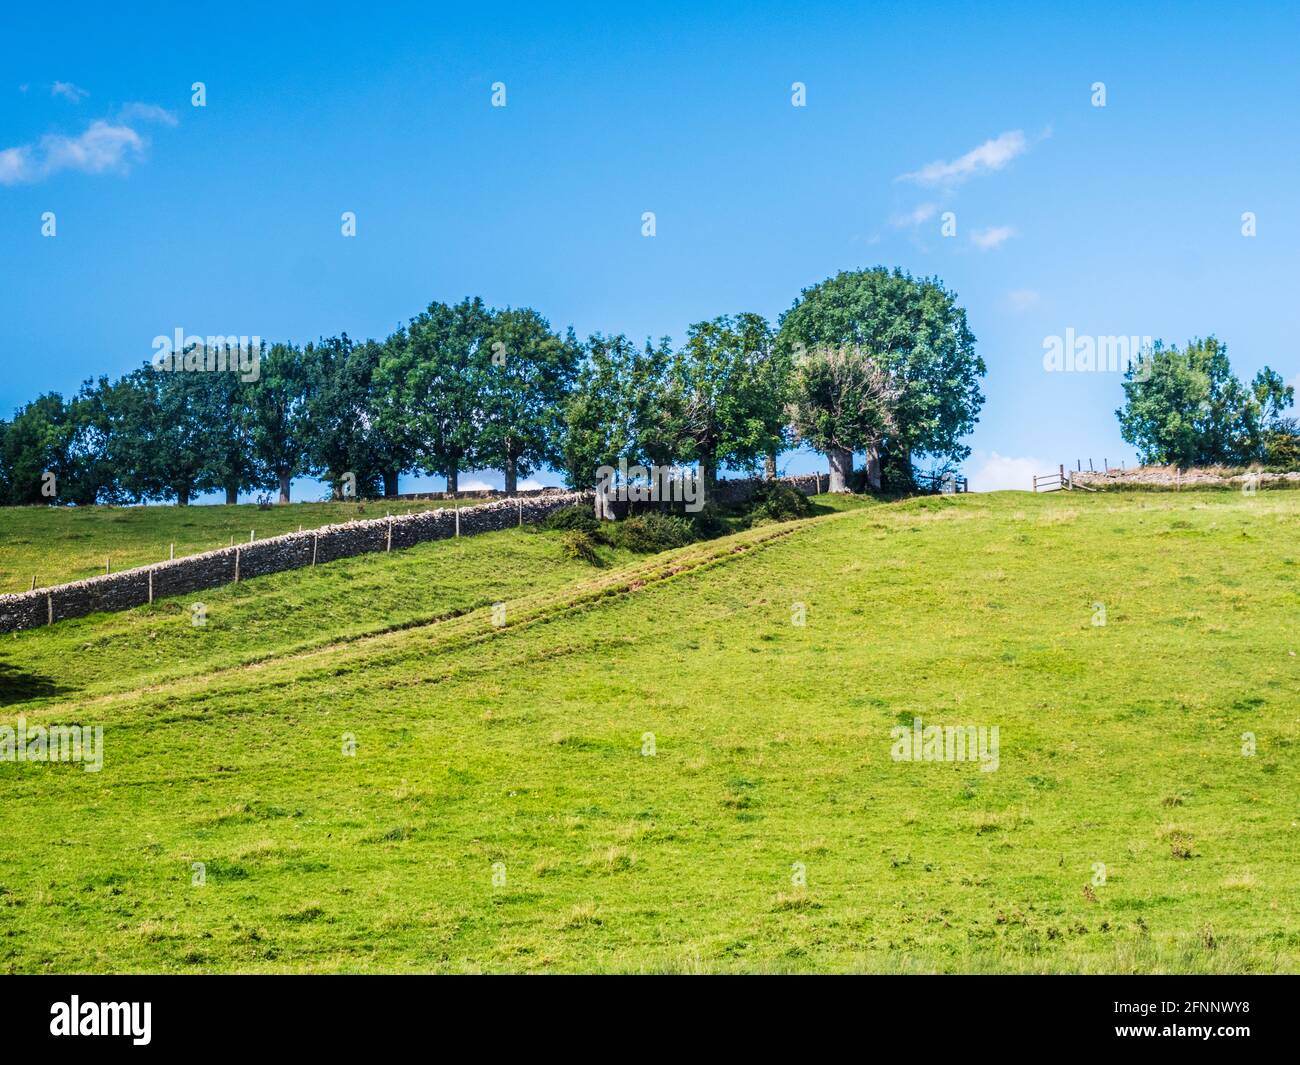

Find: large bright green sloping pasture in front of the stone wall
[0,493,1300,973]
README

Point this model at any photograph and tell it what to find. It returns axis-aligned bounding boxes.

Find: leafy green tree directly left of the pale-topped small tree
[672,312,784,492]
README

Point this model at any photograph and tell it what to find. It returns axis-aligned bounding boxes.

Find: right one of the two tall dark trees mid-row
[478,308,581,493]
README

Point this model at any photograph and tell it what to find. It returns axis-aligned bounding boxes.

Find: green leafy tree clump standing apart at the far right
[1115,337,1295,468]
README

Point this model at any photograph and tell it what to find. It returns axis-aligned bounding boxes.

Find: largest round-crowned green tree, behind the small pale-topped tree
[777,267,985,486]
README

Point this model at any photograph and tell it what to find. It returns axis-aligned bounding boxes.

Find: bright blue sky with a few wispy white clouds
[0,3,1300,498]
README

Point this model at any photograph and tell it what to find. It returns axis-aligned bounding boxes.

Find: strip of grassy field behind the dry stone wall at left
[0,499,457,594]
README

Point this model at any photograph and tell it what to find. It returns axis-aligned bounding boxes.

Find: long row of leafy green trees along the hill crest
[0,268,984,505]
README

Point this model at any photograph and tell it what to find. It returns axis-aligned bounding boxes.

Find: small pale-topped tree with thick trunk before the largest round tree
[789,346,900,492]
